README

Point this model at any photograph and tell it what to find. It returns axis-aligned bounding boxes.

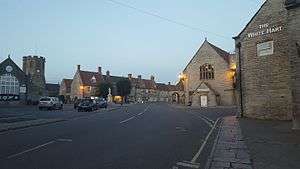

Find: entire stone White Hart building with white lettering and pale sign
[234,0,299,120]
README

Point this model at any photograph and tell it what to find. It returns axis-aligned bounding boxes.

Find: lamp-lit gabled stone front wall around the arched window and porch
[184,42,235,106]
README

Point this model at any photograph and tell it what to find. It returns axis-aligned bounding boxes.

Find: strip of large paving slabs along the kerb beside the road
[206,116,252,169]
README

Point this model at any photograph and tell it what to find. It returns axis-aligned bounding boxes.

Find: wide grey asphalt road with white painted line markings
[0,103,234,169]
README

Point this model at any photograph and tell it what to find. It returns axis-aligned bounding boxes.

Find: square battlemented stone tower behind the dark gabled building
[23,55,46,101]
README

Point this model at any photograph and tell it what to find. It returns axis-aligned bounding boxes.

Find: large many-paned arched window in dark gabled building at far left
[0,74,20,95]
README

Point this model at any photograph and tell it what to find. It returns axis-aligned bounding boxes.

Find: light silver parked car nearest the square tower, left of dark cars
[38,97,63,110]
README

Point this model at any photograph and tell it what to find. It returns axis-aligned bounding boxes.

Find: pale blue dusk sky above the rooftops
[0,0,263,83]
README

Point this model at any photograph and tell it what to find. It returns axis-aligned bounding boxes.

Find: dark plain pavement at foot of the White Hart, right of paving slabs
[239,118,300,169]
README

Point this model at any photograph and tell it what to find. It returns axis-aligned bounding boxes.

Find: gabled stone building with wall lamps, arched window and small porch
[181,39,236,107]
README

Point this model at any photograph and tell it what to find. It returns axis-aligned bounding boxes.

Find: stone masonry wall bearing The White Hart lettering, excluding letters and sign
[236,0,292,120]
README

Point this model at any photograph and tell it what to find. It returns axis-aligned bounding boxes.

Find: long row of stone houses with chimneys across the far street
[59,65,184,103]
